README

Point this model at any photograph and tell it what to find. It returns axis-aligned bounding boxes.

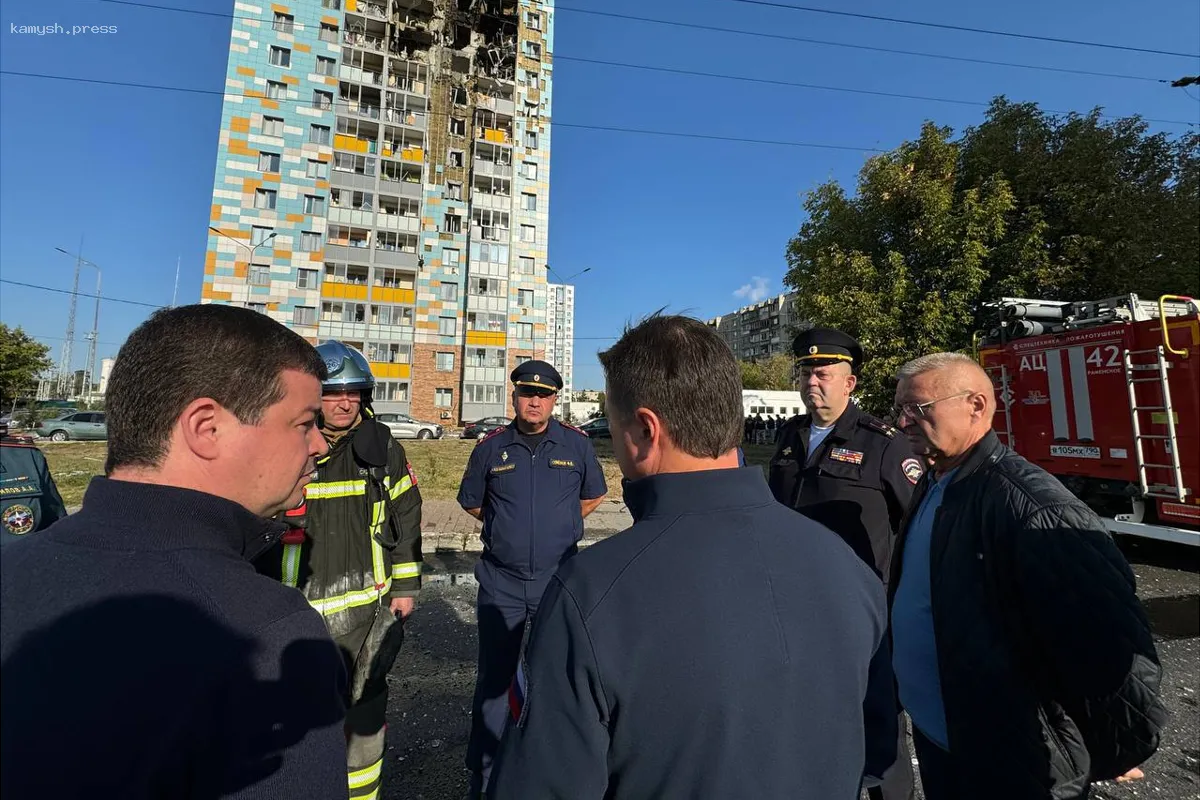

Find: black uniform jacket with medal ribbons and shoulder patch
[769,403,925,581]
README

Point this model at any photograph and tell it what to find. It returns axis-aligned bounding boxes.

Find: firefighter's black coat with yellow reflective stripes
[258,413,421,637]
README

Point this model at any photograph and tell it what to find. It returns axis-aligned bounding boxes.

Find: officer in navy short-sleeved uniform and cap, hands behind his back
[458,361,608,796]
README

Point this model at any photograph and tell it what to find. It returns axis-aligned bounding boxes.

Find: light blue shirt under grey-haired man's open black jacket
[892,469,956,750]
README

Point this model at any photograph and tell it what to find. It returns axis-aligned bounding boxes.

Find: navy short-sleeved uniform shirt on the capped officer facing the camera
[458,419,608,578]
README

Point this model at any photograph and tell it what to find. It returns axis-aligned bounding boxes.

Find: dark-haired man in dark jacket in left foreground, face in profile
[0,305,347,800]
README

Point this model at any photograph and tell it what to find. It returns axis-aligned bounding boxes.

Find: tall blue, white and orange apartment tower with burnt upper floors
[203,0,554,422]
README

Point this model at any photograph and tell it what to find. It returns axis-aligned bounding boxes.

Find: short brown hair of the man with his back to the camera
[600,314,744,458]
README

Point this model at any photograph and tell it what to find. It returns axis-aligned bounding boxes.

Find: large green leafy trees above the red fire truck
[785,97,1200,413]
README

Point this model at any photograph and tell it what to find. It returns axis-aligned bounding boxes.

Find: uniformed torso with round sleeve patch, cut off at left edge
[0,422,67,545]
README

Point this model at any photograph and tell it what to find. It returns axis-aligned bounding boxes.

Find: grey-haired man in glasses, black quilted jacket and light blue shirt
[889,353,1165,800]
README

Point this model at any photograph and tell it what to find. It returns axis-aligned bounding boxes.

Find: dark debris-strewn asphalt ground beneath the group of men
[382,542,1200,800]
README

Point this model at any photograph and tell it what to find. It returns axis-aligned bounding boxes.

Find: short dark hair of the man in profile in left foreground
[104,303,326,474]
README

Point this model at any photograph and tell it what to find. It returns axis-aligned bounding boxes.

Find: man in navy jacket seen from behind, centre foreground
[490,317,896,800]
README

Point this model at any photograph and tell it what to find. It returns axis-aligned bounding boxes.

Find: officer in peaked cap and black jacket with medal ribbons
[769,327,925,800]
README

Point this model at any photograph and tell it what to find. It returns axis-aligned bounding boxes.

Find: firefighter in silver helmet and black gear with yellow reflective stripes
[259,342,421,800]
